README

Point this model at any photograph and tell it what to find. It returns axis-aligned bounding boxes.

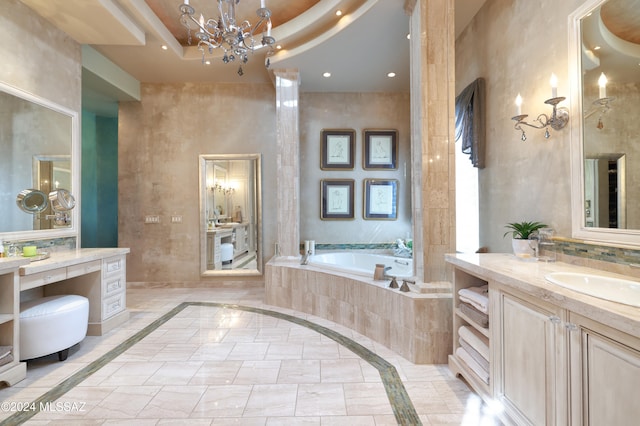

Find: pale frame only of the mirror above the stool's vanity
[0,81,81,240]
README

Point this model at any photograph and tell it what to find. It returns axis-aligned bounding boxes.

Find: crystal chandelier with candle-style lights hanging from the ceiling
[180,0,276,76]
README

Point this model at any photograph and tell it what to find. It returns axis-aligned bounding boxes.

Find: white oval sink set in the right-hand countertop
[545,272,640,307]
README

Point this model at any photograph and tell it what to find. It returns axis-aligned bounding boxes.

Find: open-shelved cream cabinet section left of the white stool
[0,258,29,386]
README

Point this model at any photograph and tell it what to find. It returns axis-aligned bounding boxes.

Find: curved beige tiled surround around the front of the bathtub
[265,258,452,364]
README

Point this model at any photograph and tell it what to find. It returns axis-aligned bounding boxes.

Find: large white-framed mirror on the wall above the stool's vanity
[0,83,80,241]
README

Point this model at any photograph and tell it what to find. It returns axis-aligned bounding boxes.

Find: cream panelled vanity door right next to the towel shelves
[490,282,567,425]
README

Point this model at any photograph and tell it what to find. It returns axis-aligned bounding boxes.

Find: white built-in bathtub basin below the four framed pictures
[309,251,413,278]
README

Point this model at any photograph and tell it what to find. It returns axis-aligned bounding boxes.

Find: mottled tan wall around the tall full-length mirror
[118,83,277,282]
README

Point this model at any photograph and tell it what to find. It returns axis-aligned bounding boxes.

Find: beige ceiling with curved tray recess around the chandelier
[21,0,485,110]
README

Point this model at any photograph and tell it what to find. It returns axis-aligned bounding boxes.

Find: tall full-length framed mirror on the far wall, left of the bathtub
[200,154,262,276]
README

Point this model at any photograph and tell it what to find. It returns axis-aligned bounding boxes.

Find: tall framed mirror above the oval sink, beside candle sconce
[569,0,640,245]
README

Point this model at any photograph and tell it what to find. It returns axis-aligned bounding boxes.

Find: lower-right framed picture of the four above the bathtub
[363,179,398,220]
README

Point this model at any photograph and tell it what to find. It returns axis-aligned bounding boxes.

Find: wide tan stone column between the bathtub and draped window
[405,0,455,283]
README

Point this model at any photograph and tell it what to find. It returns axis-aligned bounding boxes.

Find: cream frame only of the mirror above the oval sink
[569,0,640,247]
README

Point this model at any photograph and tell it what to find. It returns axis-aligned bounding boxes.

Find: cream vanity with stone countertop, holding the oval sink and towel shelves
[447,254,640,426]
